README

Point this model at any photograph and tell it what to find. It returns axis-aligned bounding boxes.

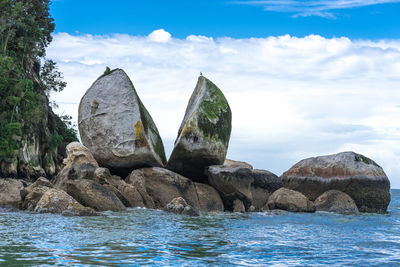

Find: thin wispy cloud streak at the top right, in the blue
[233,0,400,18]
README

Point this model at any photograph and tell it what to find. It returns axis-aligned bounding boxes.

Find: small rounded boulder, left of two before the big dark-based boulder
[266,188,315,212]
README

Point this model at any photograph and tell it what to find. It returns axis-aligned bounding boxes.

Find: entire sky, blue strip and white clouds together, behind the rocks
[47,0,400,188]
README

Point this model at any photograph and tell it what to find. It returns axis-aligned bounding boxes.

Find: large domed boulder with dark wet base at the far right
[281,152,390,212]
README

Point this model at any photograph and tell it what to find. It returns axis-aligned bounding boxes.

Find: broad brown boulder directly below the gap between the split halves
[125,167,200,209]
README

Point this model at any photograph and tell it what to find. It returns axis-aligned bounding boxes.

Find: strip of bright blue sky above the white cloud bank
[51,0,400,39]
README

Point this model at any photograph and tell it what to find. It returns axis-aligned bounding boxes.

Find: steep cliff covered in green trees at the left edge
[0,0,77,179]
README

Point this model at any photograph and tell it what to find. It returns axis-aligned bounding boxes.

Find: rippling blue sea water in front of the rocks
[0,190,400,266]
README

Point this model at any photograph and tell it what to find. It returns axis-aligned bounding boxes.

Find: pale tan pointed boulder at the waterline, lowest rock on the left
[35,188,99,216]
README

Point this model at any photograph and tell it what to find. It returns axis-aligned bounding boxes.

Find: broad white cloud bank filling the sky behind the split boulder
[47,29,400,188]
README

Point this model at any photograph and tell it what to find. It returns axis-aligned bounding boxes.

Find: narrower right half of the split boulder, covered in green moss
[167,76,232,182]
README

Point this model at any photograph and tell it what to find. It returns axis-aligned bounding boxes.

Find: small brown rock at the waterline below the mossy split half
[194,183,224,212]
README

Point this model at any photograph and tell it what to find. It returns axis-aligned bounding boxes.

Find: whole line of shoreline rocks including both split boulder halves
[0,69,390,216]
